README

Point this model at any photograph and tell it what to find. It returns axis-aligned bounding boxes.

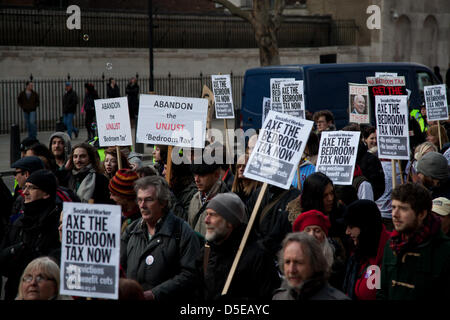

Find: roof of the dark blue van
[245,62,427,75]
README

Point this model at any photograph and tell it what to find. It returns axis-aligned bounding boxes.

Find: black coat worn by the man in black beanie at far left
[0,198,61,300]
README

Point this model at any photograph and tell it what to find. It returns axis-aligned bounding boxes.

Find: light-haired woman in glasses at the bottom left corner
[16,257,72,300]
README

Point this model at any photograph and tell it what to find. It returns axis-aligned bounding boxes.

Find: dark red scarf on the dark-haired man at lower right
[389,212,441,256]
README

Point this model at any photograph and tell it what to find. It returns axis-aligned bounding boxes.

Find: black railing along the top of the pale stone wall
[0,8,357,49]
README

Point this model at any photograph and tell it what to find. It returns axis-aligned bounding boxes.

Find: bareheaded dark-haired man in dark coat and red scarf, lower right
[377,183,450,302]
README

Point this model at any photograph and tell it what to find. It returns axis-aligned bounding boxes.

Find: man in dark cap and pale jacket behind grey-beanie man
[188,157,230,236]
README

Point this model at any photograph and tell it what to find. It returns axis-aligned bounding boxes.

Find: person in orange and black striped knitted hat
[108,169,141,232]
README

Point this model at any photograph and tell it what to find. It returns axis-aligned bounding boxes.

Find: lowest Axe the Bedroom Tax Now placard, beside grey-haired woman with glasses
[60,202,121,299]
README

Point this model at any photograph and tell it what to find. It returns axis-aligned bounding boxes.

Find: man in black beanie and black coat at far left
[0,169,61,300]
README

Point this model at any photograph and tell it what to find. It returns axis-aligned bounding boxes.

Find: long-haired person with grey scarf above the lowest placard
[60,143,113,204]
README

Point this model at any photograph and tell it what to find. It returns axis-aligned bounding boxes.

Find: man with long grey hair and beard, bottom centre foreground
[273,232,349,301]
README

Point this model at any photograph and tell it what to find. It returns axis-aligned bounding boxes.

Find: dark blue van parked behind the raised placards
[240,63,439,131]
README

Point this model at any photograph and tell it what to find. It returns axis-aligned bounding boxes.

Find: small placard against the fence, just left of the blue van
[211,74,234,119]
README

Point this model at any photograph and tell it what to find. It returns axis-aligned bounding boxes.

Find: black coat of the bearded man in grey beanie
[196,224,281,301]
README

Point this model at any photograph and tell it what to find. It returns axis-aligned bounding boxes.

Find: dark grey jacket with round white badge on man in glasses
[120,212,200,301]
